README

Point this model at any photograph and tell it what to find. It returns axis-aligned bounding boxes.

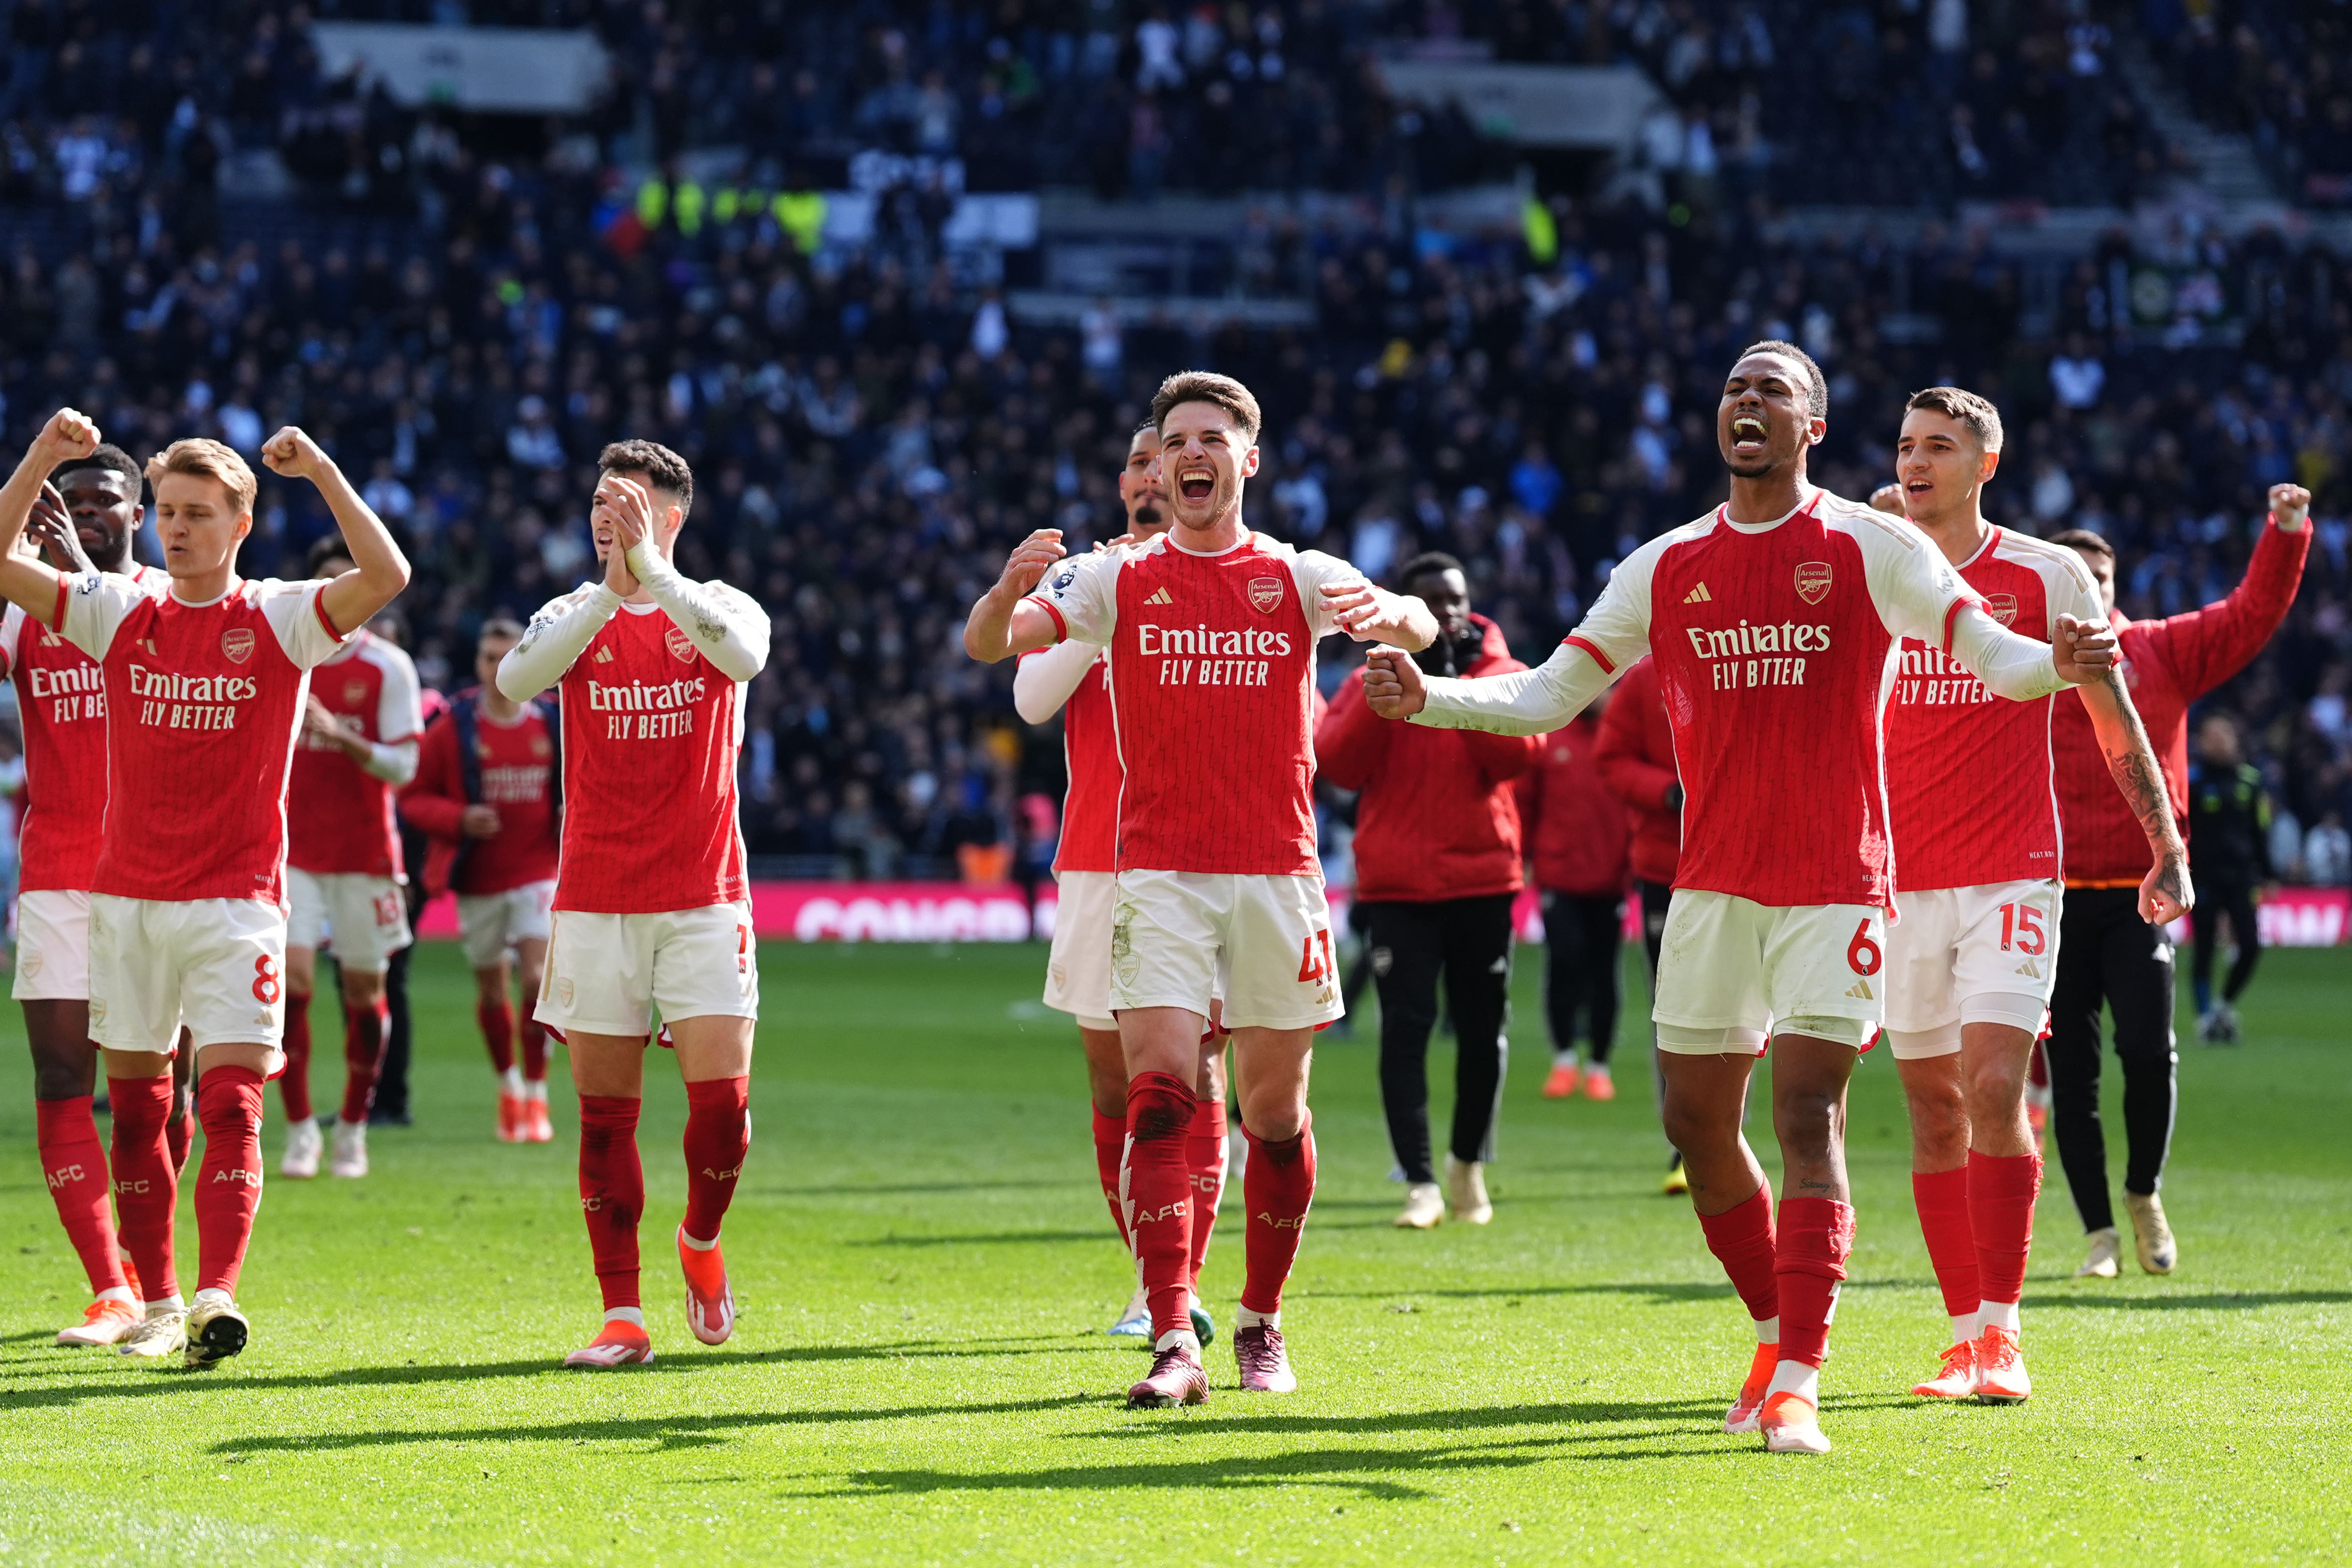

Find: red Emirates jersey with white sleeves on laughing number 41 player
[1035,534,1362,877]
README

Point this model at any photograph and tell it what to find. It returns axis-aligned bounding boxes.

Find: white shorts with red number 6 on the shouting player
[1651,889,1886,1056]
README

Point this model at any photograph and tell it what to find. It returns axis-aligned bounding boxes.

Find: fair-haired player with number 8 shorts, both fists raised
[0,409,409,1366]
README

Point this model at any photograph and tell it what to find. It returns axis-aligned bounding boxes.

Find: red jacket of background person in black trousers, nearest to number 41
[1315,616,1538,903]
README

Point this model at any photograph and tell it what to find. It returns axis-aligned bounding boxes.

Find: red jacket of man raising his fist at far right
[2051,519,2312,886]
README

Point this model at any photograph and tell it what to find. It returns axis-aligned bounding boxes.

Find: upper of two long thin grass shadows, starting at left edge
[7,1333,1096,1410]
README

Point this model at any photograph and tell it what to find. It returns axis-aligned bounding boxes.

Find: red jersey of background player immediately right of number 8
[287,628,424,877]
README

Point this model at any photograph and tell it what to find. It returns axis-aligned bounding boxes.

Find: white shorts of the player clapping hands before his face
[531,903,760,1034]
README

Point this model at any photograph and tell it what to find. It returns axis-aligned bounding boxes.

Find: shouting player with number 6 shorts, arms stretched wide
[1366,341,2115,1453]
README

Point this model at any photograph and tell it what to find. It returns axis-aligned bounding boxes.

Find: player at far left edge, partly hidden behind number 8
[0,447,172,1345]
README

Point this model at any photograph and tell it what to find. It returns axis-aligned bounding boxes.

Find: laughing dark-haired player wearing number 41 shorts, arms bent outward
[964,371,1437,1406]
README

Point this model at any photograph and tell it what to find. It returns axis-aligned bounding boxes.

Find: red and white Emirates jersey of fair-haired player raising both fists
[54,574,343,907]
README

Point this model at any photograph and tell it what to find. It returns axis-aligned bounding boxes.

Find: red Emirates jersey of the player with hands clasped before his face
[541,590,748,915]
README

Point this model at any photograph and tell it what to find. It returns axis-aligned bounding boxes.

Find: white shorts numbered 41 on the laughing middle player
[1105,872,1348,1030]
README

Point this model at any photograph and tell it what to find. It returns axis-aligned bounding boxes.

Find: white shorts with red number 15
[1886,879,2062,1060]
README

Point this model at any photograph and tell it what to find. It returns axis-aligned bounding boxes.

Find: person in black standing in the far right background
[2190,712,2272,1046]
